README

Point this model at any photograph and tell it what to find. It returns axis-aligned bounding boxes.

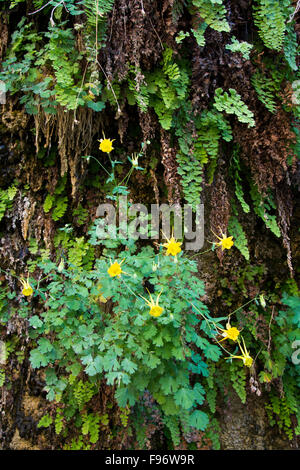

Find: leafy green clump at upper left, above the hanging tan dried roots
[0,18,104,114]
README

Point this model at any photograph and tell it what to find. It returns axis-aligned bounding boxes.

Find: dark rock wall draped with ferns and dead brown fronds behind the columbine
[0,0,300,450]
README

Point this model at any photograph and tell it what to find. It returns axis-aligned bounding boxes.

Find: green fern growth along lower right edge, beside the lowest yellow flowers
[213,274,300,440]
